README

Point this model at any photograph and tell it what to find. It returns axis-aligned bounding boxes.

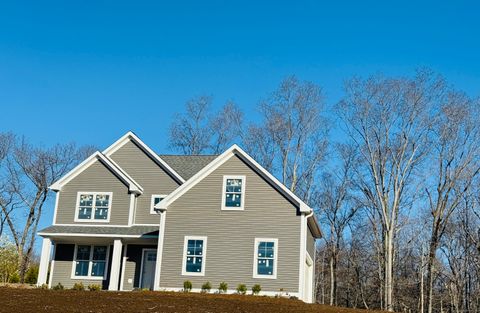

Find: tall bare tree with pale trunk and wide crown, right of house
[338,72,442,311]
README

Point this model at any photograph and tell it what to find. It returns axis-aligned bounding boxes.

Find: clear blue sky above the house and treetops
[0,1,480,241]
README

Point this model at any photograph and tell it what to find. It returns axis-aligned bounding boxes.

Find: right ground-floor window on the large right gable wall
[253,238,278,279]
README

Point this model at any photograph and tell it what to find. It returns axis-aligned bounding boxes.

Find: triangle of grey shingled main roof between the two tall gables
[159,154,218,180]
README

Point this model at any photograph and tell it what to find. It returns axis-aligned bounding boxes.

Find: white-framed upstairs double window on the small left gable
[75,192,112,222]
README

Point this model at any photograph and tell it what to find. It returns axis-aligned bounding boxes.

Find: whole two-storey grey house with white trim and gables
[38,132,321,302]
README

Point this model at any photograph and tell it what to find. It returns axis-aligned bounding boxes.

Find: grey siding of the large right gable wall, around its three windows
[160,156,300,292]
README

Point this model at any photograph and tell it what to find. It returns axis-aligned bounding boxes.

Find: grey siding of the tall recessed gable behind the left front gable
[110,141,179,224]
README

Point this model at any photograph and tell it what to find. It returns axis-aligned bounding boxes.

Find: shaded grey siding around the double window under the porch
[52,244,113,289]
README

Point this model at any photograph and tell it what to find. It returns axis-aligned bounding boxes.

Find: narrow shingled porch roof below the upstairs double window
[39,225,159,237]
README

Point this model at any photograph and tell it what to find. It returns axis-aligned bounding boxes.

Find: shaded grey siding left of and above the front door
[123,245,157,290]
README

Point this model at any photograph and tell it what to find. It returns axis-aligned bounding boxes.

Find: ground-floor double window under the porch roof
[72,245,108,279]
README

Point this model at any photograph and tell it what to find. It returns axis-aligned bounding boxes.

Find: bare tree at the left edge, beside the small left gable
[0,138,91,282]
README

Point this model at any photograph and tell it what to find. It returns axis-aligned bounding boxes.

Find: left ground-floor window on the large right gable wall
[182,236,207,276]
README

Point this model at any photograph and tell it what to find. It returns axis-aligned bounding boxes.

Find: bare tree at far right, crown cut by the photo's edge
[425,92,480,313]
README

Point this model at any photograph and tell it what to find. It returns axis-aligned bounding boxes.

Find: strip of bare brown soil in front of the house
[0,287,376,313]
